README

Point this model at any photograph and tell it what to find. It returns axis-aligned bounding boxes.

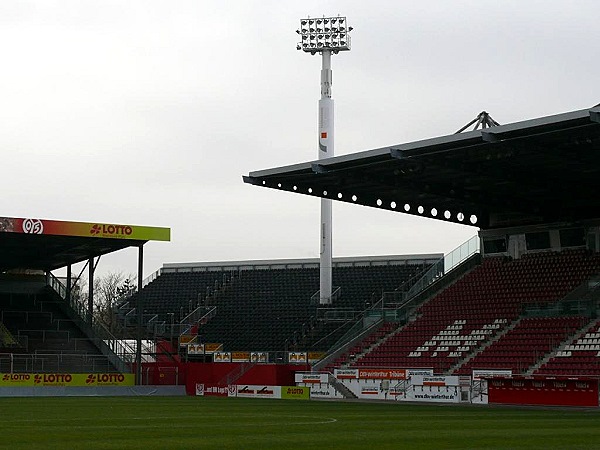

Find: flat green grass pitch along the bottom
[0,397,600,450]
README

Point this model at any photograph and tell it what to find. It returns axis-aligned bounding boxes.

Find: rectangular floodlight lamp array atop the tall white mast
[296,16,352,55]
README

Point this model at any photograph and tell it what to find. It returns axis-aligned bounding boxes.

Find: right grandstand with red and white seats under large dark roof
[244,106,600,384]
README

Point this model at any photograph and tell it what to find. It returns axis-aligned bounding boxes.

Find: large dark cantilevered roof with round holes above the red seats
[243,105,600,229]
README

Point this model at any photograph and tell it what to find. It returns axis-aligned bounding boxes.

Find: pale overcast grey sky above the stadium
[0,0,600,275]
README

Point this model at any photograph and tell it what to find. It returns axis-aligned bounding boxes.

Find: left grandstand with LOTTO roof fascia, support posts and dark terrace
[0,217,170,384]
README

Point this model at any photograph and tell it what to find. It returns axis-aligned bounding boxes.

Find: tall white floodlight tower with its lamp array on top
[296,16,352,305]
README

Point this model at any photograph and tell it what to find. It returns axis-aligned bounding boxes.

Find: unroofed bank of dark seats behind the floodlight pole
[118,254,443,358]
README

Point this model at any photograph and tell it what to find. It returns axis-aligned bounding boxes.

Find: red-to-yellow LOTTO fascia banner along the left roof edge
[0,217,171,241]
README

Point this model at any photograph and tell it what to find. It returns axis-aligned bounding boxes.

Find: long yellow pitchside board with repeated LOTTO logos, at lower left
[0,373,135,387]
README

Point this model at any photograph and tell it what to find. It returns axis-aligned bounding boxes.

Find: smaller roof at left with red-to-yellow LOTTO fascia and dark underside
[0,217,170,272]
